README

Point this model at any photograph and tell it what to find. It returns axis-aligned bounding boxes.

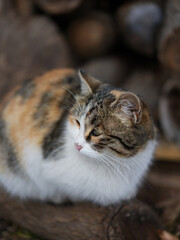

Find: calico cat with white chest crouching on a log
[0,69,156,205]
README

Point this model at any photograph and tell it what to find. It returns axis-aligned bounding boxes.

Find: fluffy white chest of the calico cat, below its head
[40,132,155,205]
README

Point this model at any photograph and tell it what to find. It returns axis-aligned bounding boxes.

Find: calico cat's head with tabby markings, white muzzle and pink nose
[68,71,155,158]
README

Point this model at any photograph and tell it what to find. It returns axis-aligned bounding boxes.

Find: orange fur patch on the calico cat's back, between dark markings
[2,69,75,162]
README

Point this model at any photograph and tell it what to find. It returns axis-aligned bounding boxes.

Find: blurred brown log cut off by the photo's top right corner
[158,0,180,71]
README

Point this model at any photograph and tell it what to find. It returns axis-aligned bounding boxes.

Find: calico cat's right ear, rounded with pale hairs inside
[111,91,142,123]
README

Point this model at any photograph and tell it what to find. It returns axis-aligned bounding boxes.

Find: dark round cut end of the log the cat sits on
[108,201,162,240]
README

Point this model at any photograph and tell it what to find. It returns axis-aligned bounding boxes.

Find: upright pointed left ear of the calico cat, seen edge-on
[78,70,101,95]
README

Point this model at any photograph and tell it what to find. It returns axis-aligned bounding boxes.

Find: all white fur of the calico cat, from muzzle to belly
[0,111,155,205]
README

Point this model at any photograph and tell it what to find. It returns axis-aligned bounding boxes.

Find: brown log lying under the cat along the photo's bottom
[0,188,162,240]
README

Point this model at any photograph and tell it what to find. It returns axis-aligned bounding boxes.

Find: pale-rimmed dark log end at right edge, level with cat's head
[159,79,180,146]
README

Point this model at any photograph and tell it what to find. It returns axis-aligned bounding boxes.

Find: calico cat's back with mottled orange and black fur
[0,69,79,168]
